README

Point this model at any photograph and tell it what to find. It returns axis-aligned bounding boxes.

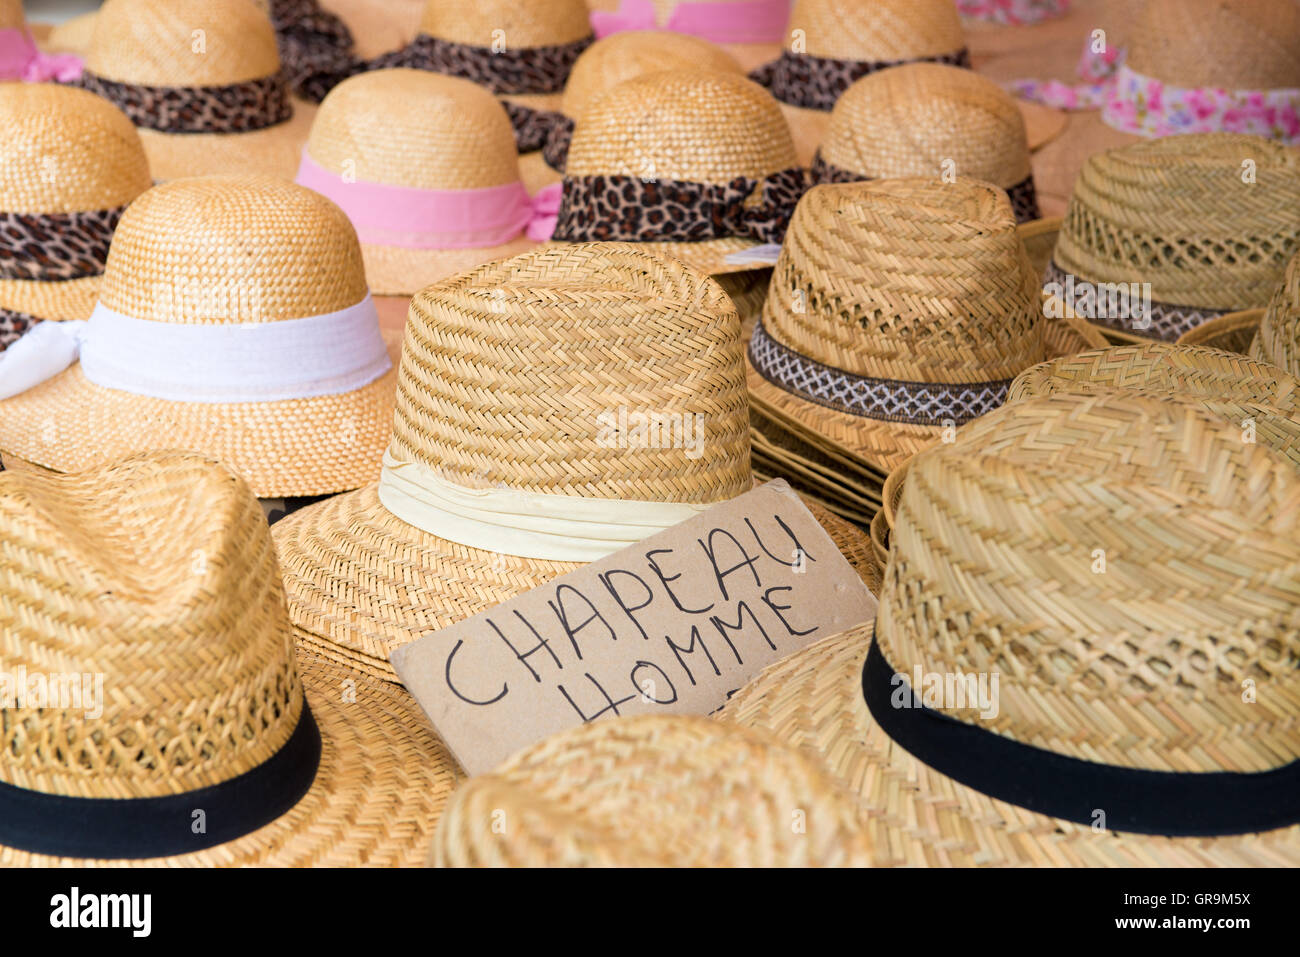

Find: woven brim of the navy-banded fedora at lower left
[0,648,463,867]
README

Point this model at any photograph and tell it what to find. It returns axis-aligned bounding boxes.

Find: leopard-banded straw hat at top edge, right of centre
[751,0,970,165]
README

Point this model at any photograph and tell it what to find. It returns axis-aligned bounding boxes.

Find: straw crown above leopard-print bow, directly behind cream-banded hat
[566,70,798,185]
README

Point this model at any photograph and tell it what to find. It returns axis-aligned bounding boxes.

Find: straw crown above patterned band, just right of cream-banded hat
[763,177,1043,384]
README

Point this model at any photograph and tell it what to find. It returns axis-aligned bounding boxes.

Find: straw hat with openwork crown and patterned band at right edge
[1045,133,1300,342]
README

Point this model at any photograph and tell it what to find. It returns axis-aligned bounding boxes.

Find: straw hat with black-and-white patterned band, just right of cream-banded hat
[749,177,1045,477]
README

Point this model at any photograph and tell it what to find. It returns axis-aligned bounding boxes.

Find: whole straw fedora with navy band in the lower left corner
[0,452,459,867]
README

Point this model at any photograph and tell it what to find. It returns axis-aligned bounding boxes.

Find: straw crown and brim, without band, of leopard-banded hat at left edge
[0,83,151,319]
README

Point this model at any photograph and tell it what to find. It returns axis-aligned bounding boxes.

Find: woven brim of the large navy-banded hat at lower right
[718,625,1300,867]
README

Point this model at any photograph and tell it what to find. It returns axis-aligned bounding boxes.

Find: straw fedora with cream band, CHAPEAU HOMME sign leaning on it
[274,243,871,680]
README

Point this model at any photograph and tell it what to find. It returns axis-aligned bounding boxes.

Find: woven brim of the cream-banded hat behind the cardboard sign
[272,485,875,681]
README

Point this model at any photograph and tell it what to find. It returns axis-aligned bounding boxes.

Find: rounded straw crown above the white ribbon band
[100,176,367,324]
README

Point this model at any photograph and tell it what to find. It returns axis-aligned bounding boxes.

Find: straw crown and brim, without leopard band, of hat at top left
[86,0,315,179]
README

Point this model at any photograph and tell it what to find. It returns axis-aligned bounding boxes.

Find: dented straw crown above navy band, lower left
[0,452,303,798]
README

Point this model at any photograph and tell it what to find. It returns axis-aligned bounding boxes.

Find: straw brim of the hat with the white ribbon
[0,332,402,498]
